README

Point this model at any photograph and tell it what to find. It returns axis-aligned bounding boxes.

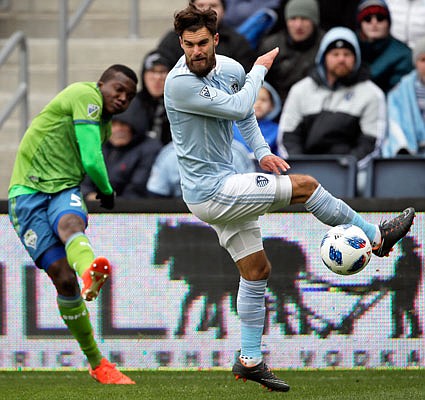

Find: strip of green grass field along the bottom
[0,369,425,400]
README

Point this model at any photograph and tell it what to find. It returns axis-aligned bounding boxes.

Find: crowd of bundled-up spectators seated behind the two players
[89,0,425,198]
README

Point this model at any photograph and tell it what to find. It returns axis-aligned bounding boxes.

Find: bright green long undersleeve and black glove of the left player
[75,123,113,194]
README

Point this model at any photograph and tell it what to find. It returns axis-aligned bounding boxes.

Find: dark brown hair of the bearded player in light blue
[174,4,217,36]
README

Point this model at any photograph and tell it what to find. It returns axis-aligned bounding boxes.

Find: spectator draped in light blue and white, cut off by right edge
[382,36,425,157]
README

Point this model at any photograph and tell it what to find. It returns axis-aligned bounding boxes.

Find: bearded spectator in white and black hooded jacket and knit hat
[278,27,386,177]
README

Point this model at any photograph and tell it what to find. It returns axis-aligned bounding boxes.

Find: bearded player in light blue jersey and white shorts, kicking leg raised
[164,5,415,392]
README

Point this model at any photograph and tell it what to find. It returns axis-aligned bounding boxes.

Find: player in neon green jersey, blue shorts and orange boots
[9,64,137,384]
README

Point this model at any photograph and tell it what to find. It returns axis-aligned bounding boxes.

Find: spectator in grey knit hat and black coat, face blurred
[258,0,324,102]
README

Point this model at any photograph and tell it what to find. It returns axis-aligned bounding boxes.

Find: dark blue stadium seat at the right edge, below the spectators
[366,156,425,198]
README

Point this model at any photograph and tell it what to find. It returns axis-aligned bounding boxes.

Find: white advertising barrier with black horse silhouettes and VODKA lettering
[0,199,425,369]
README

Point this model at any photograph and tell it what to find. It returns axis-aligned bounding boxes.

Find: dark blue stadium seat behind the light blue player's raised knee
[286,155,357,198]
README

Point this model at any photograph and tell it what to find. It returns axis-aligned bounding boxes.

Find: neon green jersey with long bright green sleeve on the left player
[9,82,112,197]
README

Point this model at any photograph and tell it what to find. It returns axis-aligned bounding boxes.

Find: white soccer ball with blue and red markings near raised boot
[320,224,372,275]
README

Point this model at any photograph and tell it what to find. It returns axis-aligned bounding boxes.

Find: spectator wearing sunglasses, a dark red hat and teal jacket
[357,0,413,94]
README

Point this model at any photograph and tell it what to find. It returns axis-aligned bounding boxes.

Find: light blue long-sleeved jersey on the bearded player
[164,55,271,204]
